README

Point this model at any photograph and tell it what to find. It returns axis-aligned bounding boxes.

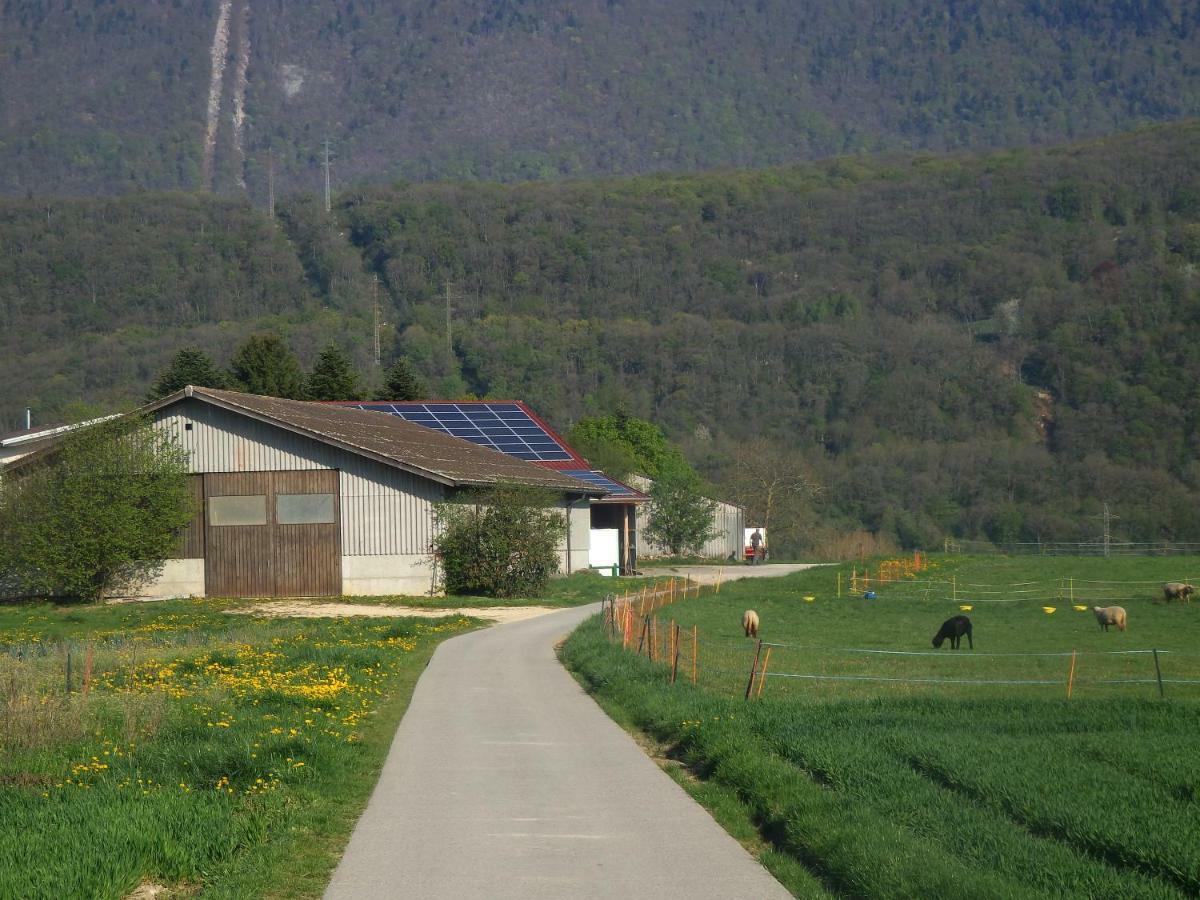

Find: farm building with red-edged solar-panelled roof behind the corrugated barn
[332,400,649,574]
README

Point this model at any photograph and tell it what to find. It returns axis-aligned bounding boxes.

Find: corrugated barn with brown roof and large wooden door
[138,388,605,596]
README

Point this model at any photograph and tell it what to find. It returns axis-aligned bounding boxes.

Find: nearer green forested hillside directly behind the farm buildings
[0,122,1200,546]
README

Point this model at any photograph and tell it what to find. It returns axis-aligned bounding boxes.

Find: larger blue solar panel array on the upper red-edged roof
[348,403,578,465]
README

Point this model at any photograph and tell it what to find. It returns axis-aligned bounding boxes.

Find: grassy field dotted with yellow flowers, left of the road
[0,600,473,898]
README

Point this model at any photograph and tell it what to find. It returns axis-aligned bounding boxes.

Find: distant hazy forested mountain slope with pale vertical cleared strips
[0,0,1200,196]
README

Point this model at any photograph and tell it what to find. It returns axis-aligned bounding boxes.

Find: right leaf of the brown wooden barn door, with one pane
[275,469,342,596]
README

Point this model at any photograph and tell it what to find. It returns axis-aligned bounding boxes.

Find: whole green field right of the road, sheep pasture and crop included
[564,558,1200,898]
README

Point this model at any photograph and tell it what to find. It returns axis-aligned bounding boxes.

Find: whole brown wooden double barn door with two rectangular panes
[204,469,342,596]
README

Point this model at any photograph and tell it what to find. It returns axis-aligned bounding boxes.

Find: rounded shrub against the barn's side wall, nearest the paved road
[433,485,566,596]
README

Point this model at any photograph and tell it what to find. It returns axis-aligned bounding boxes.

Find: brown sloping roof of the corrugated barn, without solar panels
[143,385,605,497]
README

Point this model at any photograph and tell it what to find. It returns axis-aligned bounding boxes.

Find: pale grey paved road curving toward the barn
[325,606,788,900]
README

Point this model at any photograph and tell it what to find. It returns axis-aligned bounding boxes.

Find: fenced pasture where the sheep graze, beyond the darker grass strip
[637,557,1200,701]
